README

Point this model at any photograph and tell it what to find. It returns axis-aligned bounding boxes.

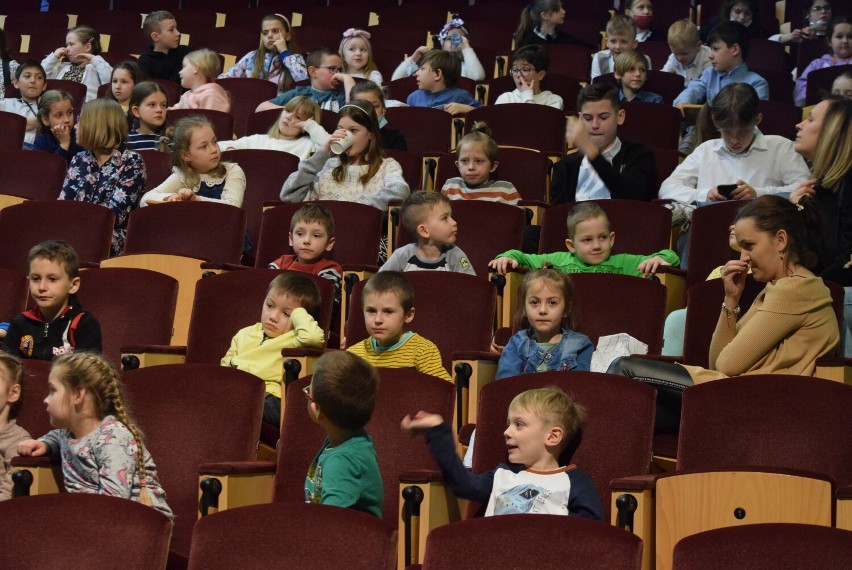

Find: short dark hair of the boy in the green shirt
[311,350,379,431]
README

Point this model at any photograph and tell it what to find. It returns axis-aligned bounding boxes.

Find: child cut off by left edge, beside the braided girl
[0,352,31,501]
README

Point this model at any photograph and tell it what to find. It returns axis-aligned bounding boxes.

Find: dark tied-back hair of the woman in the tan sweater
[734,194,823,269]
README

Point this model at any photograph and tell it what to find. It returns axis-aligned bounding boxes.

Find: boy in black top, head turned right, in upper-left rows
[136,10,190,83]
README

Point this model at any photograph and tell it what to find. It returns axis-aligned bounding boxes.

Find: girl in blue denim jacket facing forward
[495,269,594,379]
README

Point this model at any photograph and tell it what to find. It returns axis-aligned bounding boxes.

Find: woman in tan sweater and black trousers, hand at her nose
[608,195,840,433]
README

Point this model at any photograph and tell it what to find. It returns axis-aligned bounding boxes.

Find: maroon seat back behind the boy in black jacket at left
[0,200,115,274]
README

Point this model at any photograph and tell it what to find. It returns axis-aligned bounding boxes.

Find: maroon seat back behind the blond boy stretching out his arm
[473,372,657,521]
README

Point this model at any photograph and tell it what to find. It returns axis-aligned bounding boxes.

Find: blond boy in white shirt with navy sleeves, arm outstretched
[401,386,603,520]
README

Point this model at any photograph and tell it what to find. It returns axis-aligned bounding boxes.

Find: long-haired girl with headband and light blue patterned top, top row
[219,14,308,93]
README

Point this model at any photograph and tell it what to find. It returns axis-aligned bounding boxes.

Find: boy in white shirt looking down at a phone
[660,82,810,204]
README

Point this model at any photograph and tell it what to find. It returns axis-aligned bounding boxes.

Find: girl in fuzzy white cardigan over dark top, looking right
[140,115,246,208]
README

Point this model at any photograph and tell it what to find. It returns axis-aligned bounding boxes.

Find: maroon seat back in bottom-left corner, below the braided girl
[0,493,172,568]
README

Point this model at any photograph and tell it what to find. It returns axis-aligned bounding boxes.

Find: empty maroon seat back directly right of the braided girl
[121,362,264,562]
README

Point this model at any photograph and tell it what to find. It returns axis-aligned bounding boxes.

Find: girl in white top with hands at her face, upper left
[41,26,112,101]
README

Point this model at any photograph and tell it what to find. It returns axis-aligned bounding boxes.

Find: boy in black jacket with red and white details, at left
[3,240,101,360]
